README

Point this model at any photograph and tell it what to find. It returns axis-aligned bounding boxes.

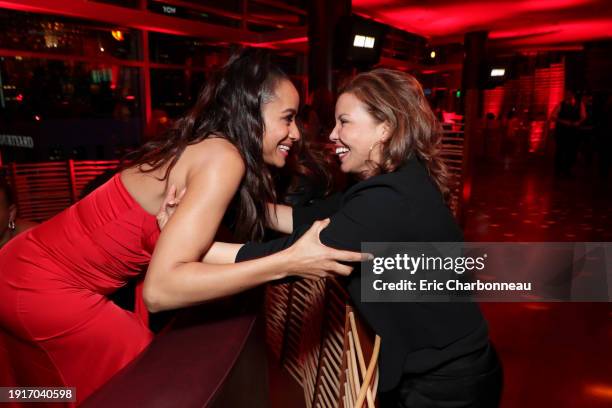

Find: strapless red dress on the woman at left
[0,173,159,402]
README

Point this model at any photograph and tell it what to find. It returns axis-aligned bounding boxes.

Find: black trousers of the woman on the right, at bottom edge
[378,344,503,408]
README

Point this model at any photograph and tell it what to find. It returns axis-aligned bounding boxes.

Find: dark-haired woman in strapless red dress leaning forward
[0,50,360,402]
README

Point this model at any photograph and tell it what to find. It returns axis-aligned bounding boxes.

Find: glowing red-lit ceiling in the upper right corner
[352,0,612,45]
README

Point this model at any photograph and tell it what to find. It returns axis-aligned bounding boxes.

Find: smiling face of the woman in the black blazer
[329,93,388,174]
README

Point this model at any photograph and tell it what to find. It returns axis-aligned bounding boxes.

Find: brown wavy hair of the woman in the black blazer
[339,68,450,198]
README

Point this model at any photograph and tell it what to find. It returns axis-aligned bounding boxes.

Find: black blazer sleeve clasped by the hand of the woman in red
[236,186,401,262]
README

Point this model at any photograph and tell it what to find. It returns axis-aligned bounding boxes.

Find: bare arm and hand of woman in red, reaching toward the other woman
[143,140,363,312]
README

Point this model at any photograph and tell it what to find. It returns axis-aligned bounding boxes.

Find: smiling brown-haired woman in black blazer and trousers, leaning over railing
[164,69,502,408]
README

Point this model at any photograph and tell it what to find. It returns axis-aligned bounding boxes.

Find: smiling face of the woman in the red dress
[262,79,300,167]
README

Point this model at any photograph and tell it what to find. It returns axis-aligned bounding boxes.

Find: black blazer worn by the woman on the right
[236,158,488,391]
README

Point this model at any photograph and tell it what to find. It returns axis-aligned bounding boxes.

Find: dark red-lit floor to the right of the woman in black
[464,154,612,408]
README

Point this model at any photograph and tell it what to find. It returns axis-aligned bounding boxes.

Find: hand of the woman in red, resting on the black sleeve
[285,218,372,279]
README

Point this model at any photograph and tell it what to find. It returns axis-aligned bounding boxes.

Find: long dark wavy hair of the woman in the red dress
[128,48,288,240]
